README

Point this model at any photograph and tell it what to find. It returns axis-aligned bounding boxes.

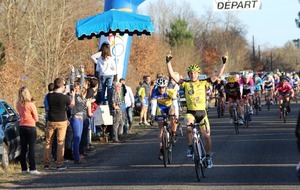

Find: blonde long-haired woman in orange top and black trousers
[17,86,40,175]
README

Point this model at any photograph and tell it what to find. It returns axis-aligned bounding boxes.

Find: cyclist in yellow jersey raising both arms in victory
[166,53,227,168]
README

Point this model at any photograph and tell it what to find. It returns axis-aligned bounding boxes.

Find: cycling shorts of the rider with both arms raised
[185,110,210,131]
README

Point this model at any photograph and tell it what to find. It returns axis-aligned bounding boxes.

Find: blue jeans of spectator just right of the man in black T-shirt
[70,117,83,161]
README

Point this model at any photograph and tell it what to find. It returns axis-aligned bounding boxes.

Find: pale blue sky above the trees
[138,0,300,49]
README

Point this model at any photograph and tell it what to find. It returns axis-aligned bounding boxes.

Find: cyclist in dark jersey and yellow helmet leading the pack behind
[225,76,244,125]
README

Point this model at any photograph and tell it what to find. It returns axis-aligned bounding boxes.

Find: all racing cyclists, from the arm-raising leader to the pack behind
[150,51,299,168]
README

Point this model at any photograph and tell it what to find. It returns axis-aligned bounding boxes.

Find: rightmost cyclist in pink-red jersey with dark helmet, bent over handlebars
[274,76,294,113]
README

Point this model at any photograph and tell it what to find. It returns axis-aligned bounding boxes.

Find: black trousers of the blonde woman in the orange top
[19,126,37,171]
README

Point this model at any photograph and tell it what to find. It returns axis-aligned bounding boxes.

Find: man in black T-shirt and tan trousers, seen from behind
[44,78,75,170]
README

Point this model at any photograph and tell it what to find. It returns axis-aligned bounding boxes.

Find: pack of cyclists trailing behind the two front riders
[209,72,300,125]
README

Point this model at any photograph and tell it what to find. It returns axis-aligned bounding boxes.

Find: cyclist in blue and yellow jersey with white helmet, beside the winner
[150,78,179,160]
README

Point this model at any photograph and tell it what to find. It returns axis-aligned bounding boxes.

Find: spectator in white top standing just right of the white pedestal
[120,78,134,133]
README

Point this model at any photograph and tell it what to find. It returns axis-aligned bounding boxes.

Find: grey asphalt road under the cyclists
[10,101,300,190]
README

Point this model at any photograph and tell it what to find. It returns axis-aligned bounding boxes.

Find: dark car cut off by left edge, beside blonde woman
[0,100,21,169]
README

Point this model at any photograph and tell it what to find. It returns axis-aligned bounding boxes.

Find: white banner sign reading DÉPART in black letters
[213,0,261,11]
